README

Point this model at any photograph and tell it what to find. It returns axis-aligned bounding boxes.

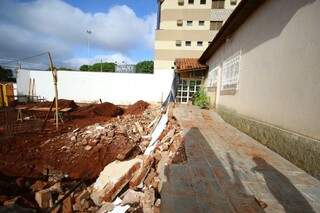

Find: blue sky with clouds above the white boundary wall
[0,0,157,68]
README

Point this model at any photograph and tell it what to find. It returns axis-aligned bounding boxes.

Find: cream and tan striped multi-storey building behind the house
[155,0,240,72]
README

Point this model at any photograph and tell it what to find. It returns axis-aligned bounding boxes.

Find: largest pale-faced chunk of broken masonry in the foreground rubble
[91,158,142,206]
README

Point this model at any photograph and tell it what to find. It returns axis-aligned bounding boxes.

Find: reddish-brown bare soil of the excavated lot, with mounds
[0,100,149,178]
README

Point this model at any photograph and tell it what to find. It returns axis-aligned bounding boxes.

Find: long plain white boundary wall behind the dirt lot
[17,69,173,104]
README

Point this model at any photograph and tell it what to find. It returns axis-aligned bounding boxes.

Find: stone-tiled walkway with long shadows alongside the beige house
[161,105,320,213]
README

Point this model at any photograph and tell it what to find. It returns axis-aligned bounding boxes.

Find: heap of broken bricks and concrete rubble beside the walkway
[0,104,185,213]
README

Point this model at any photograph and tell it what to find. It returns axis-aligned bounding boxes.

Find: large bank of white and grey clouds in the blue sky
[0,0,156,67]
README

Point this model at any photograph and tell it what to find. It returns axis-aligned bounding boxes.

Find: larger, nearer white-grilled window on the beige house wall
[221,52,241,91]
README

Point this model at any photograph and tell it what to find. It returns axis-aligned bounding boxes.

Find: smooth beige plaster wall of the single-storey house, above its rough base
[207,0,320,140]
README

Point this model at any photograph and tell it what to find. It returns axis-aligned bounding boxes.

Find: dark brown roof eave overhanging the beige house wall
[199,0,268,64]
